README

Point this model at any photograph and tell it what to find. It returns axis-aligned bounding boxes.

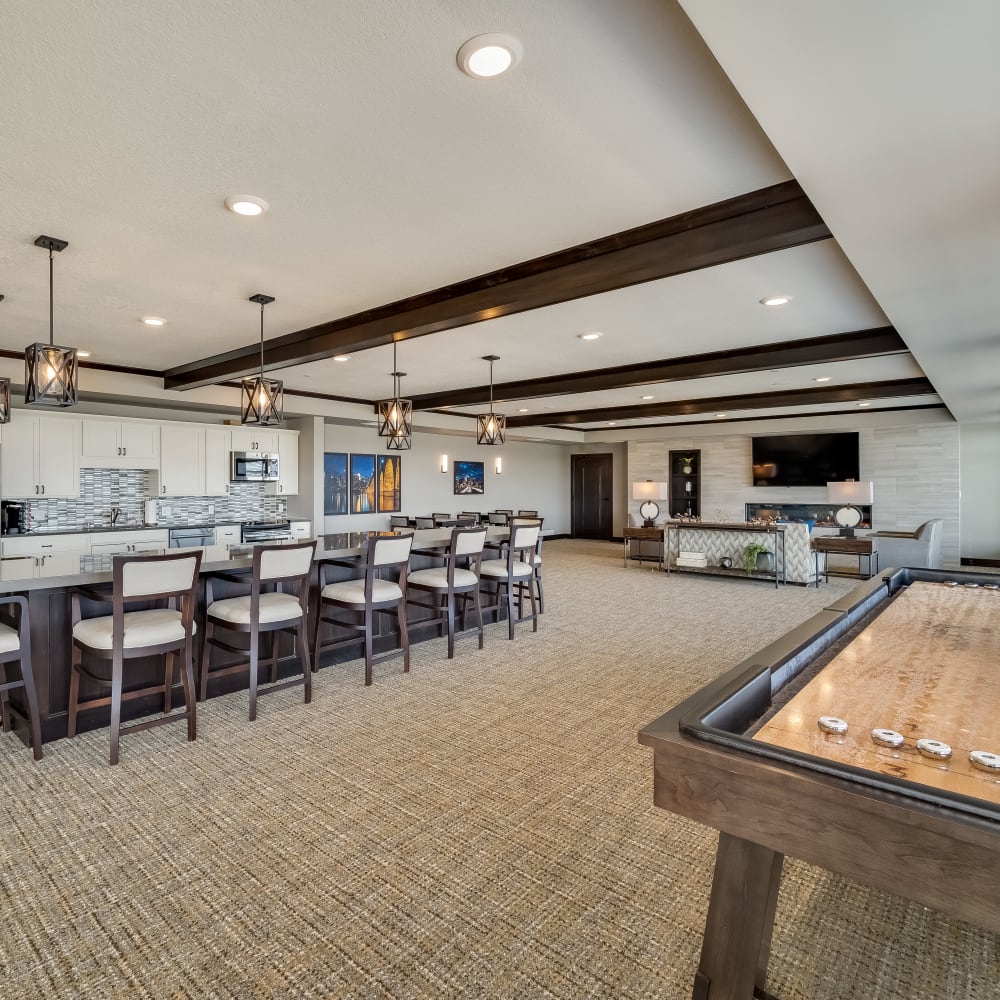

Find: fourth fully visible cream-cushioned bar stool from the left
[407,527,486,660]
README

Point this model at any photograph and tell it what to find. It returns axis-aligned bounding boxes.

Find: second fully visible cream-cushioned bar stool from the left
[201,540,316,722]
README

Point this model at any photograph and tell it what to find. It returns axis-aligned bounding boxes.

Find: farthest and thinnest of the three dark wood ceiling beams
[507,378,935,428]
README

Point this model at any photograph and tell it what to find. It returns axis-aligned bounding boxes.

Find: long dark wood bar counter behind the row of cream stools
[0,527,509,742]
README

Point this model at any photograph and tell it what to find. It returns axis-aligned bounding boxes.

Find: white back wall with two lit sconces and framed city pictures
[324,424,570,534]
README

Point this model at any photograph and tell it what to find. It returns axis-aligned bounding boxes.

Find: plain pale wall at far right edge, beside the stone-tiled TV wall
[961,423,1000,559]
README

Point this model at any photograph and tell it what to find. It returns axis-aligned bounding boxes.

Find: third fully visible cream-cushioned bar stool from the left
[313,534,413,686]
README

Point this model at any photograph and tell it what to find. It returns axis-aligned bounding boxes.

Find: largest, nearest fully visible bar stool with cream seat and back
[67,549,201,764]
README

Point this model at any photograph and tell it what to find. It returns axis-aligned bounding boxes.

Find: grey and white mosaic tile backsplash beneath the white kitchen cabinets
[21,469,286,531]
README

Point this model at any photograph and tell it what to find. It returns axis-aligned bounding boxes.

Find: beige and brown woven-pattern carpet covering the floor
[0,541,1000,1000]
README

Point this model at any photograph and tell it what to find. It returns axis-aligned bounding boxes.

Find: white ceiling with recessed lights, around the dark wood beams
[0,0,984,432]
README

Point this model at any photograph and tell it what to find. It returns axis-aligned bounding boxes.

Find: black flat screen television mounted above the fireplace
[752,432,861,486]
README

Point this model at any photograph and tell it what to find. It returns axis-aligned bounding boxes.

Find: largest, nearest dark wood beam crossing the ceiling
[164,181,830,389]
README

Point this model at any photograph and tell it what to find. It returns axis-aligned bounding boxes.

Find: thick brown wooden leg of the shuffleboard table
[692,833,784,1000]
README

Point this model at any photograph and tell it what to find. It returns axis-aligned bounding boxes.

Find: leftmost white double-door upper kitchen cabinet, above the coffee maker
[0,412,82,499]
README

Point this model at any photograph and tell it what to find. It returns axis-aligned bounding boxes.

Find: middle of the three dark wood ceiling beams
[413,326,909,410]
